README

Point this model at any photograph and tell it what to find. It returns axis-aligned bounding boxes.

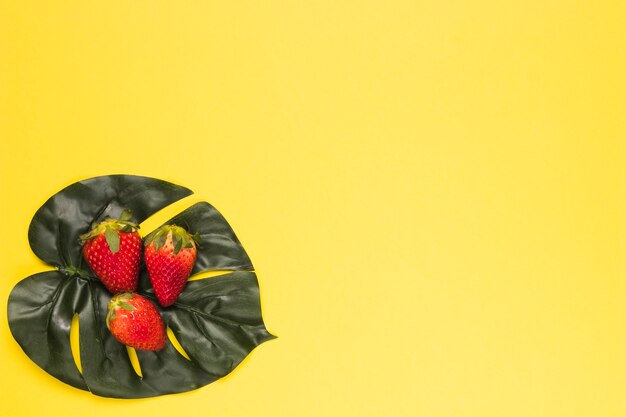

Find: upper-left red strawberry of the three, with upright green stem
[80,210,141,293]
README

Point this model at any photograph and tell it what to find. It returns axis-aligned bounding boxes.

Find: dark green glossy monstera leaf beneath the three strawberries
[8,175,274,398]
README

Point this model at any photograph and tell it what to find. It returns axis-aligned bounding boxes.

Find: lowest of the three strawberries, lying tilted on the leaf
[106,292,165,350]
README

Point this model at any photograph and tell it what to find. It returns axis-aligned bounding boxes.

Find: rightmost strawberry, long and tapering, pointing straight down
[144,225,196,307]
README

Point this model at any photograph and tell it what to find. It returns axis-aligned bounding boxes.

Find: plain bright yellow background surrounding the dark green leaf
[0,0,626,417]
